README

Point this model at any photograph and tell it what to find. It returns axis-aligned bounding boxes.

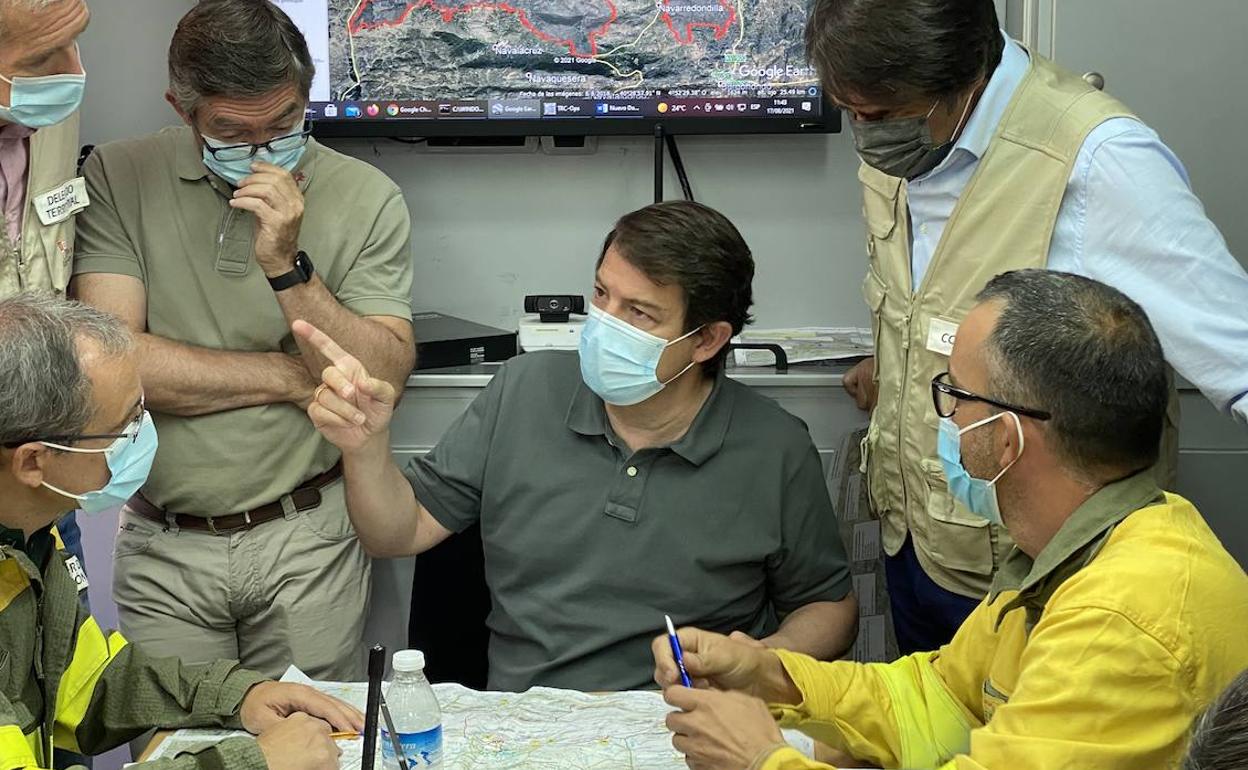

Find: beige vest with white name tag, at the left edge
[0,112,86,297]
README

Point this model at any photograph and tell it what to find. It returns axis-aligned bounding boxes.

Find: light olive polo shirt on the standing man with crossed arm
[74,127,412,515]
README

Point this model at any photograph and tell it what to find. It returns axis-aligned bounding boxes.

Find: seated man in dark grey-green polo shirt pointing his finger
[295,202,856,690]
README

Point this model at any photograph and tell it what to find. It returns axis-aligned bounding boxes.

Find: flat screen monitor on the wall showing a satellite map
[277,0,840,136]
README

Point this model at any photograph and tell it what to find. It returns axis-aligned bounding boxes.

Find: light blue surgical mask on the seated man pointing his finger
[580,305,701,407]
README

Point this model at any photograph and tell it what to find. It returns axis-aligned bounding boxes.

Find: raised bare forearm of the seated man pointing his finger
[342,433,423,558]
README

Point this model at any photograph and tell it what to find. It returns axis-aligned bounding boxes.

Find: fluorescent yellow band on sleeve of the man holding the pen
[876,653,971,768]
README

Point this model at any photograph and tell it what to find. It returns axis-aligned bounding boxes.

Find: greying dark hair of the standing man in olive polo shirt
[168,0,316,115]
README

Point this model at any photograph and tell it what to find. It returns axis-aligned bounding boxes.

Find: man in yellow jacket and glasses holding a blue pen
[654,270,1248,770]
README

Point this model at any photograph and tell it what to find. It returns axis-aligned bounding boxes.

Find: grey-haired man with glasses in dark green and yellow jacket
[0,293,363,770]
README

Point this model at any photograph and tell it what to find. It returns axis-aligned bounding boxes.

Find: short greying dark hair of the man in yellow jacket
[978,270,1169,483]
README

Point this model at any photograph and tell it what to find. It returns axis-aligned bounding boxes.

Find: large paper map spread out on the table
[151,671,814,770]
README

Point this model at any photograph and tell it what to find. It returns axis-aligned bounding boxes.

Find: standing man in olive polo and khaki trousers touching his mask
[74,0,414,679]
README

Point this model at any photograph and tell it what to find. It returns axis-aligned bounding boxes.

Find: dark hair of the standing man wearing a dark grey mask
[806,0,1005,105]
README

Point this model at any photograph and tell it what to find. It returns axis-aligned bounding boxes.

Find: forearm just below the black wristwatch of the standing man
[276,276,416,393]
